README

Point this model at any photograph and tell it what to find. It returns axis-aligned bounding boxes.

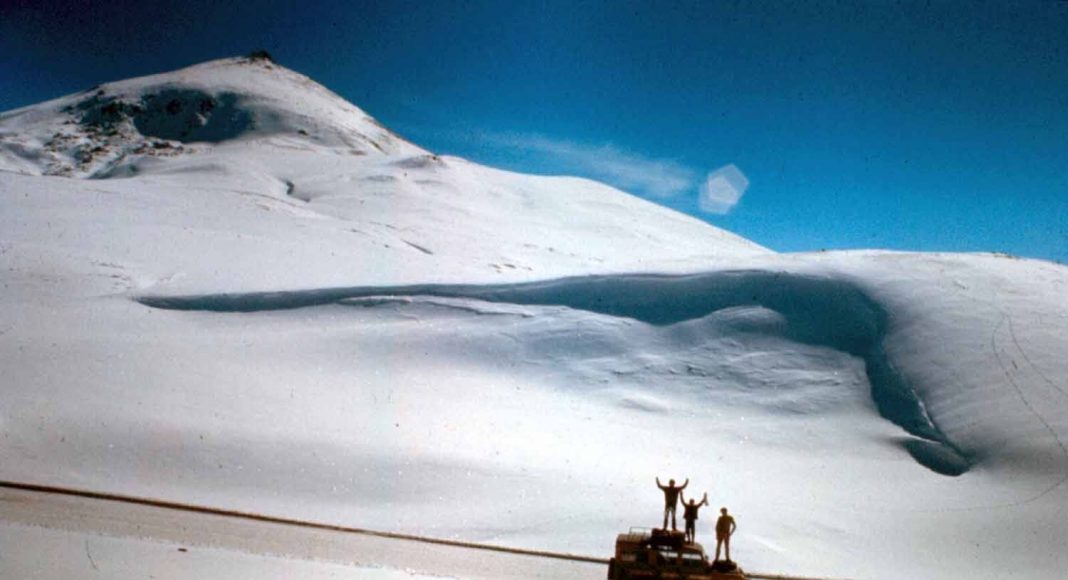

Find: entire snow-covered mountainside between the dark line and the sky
[0,59,1068,578]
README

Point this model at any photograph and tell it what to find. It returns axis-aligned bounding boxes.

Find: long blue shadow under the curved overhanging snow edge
[136,270,972,475]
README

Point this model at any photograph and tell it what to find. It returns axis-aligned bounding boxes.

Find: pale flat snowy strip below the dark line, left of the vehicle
[0,485,604,579]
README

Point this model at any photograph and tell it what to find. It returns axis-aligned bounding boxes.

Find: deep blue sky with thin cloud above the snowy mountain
[0,0,1068,263]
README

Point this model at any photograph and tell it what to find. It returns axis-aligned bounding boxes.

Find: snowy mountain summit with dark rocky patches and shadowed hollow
[0,57,425,177]
